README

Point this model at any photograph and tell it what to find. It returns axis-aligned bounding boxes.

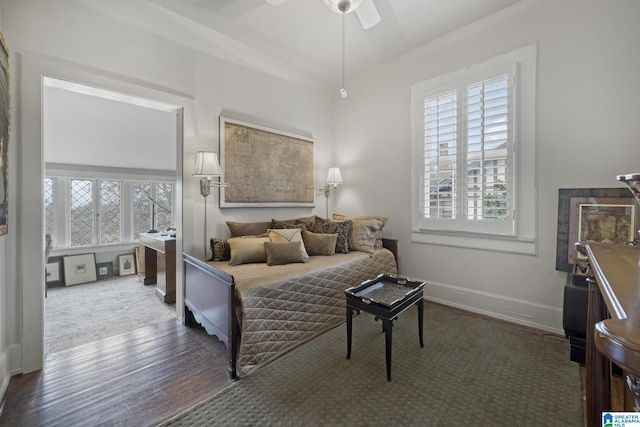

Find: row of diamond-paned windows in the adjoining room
[44,177,174,248]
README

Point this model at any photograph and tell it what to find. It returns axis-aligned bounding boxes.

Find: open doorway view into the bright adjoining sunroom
[42,77,179,354]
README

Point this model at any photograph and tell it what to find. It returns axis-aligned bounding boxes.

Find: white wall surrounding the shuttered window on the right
[335,0,640,333]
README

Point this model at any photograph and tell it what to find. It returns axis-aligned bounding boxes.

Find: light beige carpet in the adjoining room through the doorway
[44,275,176,354]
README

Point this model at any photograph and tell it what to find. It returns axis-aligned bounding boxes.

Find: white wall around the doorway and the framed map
[0,0,333,391]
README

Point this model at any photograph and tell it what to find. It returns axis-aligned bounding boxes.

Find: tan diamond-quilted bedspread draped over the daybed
[211,249,397,377]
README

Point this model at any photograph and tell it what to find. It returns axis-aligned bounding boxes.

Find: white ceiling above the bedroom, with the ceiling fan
[147,0,521,83]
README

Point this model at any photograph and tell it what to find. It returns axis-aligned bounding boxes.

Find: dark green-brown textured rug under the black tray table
[163,303,582,427]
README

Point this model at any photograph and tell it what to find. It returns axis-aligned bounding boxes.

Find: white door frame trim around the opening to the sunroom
[13,56,188,374]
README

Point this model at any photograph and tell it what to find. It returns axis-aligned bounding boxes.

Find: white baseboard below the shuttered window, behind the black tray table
[424,282,564,335]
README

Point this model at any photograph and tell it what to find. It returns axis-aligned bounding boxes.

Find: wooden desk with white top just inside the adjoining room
[140,233,176,304]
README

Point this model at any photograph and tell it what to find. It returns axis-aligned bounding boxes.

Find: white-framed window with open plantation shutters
[411,46,537,254]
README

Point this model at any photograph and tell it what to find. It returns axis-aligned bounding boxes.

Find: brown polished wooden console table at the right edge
[584,243,640,427]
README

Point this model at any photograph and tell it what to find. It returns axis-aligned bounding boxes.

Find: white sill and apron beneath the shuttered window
[411,229,538,256]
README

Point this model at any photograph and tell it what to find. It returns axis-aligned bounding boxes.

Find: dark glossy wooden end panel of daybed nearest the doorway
[183,254,239,379]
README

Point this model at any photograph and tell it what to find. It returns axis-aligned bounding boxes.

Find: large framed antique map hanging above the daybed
[219,116,316,208]
